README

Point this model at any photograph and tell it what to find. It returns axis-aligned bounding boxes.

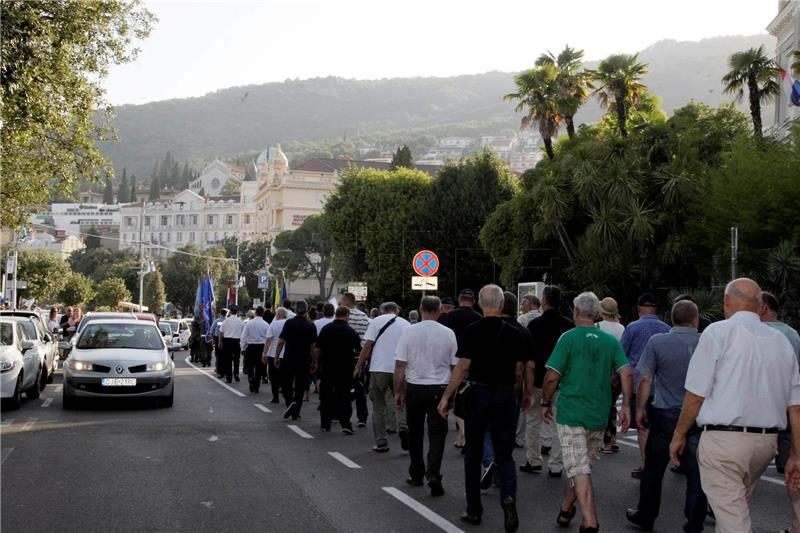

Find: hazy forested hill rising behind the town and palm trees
[104,35,774,176]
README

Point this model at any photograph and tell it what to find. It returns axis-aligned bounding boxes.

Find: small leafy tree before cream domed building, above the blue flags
[272,215,336,300]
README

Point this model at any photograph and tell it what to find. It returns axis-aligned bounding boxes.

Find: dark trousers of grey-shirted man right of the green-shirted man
[637,407,706,532]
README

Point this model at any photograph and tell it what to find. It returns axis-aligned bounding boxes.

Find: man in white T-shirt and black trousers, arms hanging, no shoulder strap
[394,296,458,496]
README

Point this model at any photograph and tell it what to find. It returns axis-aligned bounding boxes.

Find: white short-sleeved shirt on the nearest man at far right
[686,311,800,429]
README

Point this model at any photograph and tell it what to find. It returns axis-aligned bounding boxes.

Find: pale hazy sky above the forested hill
[105,0,778,105]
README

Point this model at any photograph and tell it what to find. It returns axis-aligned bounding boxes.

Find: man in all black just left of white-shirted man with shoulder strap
[311,306,361,435]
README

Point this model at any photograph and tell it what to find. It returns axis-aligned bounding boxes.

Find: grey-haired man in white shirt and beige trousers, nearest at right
[670,278,800,533]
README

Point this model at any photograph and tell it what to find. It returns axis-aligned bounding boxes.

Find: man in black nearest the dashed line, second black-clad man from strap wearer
[275,300,317,420]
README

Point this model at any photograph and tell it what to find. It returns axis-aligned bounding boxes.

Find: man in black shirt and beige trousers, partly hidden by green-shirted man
[520,285,575,477]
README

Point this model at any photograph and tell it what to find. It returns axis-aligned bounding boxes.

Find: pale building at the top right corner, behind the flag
[767,0,800,137]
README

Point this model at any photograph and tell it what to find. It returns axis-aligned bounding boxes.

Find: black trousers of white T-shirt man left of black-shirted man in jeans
[406,383,447,481]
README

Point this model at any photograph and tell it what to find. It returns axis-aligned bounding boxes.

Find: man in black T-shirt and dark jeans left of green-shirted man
[439,285,530,533]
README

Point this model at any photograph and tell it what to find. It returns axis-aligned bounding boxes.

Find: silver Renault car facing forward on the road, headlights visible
[63,319,175,409]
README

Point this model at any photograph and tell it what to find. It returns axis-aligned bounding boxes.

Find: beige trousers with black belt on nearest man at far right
[697,431,778,533]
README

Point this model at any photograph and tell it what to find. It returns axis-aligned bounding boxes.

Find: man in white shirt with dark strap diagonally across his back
[353,302,410,452]
